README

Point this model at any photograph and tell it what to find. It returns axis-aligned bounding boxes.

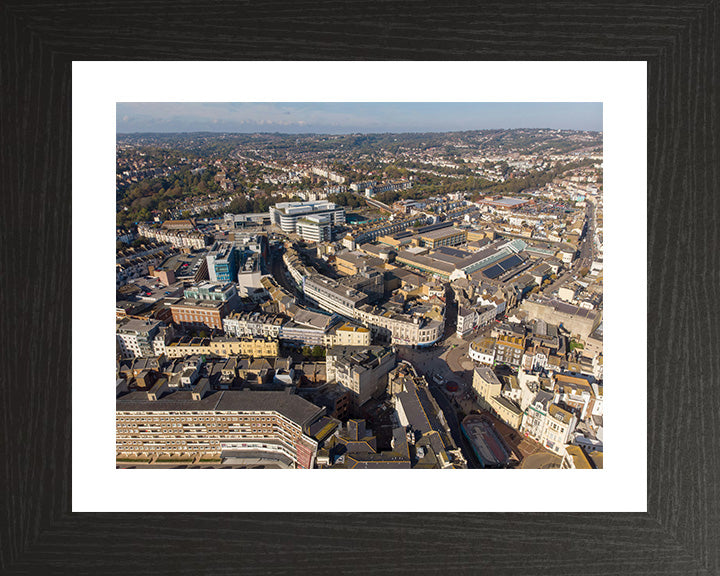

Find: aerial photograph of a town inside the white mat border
[116,102,603,470]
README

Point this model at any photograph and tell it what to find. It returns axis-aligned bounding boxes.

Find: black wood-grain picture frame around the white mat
[0,0,720,575]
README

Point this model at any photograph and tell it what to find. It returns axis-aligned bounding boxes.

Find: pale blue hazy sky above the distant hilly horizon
[116,102,602,134]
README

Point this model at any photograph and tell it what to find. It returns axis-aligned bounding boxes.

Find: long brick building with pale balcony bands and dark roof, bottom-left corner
[115,390,324,468]
